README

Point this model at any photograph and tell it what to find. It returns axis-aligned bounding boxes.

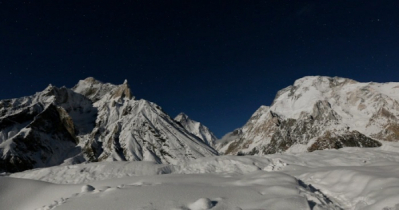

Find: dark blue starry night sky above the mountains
[0,0,399,137]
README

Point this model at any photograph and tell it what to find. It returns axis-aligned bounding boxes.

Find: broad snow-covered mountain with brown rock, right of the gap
[217,76,399,154]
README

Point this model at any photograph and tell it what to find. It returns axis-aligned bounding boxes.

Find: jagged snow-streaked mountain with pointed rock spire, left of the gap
[0,78,217,171]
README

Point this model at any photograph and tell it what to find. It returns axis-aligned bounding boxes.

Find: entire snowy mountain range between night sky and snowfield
[0,76,399,172]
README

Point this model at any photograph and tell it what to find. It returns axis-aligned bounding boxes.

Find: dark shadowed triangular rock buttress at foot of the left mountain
[0,104,77,172]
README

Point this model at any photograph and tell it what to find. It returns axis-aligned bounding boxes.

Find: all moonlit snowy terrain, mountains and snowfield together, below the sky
[0,77,399,210]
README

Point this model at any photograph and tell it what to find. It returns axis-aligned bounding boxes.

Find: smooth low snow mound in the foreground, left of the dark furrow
[0,171,318,210]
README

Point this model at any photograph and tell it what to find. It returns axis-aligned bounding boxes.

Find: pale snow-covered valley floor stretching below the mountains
[0,143,399,210]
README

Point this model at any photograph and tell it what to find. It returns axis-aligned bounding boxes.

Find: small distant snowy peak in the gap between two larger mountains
[175,113,217,146]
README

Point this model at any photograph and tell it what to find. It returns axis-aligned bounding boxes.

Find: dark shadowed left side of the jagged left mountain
[0,85,97,172]
